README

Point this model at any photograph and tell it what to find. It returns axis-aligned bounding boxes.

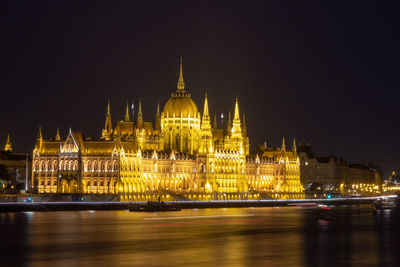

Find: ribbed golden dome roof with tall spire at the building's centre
[163,58,199,118]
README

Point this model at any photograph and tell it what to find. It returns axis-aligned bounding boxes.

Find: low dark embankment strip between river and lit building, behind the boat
[0,196,396,212]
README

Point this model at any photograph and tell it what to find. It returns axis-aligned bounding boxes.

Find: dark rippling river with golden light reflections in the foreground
[0,207,400,266]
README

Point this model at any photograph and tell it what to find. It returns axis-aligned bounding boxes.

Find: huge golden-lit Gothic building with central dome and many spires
[31,59,304,201]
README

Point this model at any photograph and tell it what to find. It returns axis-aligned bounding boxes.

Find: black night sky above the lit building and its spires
[0,1,400,175]
